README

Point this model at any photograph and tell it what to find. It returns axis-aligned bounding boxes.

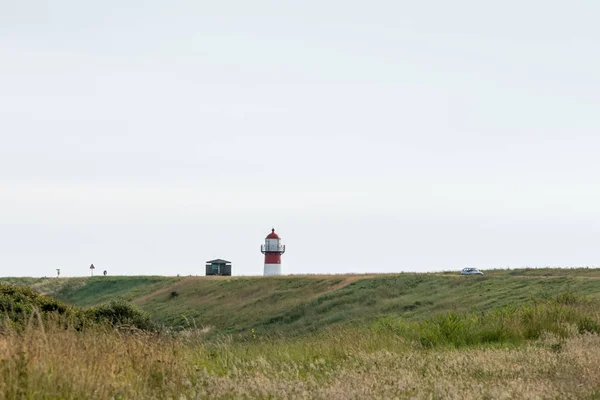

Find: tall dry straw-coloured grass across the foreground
[0,314,600,399]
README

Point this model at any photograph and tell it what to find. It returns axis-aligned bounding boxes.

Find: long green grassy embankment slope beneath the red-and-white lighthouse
[0,269,600,336]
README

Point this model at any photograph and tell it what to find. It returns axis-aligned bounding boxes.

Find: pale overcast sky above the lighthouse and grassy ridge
[0,0,600,276]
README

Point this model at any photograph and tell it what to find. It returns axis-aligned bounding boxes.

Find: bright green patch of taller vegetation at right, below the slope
[372,293,600,348]
